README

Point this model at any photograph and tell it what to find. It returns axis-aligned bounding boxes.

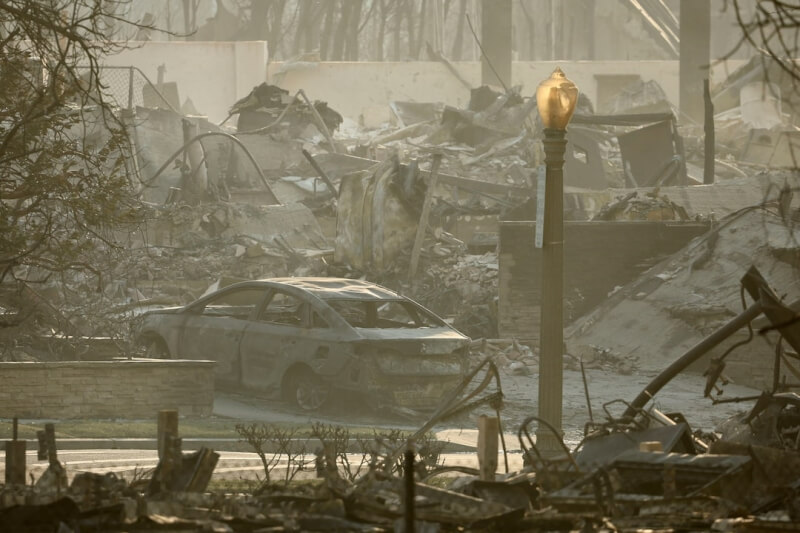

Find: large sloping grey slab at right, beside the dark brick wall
[566,206,800,387]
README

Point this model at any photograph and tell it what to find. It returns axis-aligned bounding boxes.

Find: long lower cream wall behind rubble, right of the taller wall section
[268,61,743,126]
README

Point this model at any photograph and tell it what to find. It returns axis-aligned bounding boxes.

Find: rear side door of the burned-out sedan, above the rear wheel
[240,289,327,392]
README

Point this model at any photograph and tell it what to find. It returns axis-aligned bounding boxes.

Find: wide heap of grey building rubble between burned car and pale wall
[9,54,796,358]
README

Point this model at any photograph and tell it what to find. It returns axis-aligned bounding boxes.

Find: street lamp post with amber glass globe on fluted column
[536,68,578,455]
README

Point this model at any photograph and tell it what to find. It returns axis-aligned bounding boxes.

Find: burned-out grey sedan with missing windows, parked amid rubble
[137,278,469,410]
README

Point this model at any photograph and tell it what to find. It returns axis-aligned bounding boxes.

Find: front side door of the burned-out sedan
[178,287,269,384]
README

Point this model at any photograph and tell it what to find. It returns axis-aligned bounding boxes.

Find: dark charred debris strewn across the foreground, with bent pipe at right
[7,316,800,531]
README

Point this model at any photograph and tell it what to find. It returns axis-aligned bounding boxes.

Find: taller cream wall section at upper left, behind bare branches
[104,41,267,123]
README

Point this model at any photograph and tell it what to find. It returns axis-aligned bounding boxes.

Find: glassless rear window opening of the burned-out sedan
[325,298,449,329]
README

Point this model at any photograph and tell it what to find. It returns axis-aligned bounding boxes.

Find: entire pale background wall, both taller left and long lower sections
[97,45,743,126]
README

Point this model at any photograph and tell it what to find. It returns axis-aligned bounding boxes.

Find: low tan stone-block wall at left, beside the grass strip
[0,359,214,418]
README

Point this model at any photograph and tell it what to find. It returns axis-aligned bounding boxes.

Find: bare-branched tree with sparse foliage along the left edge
[0,0,158,348]
